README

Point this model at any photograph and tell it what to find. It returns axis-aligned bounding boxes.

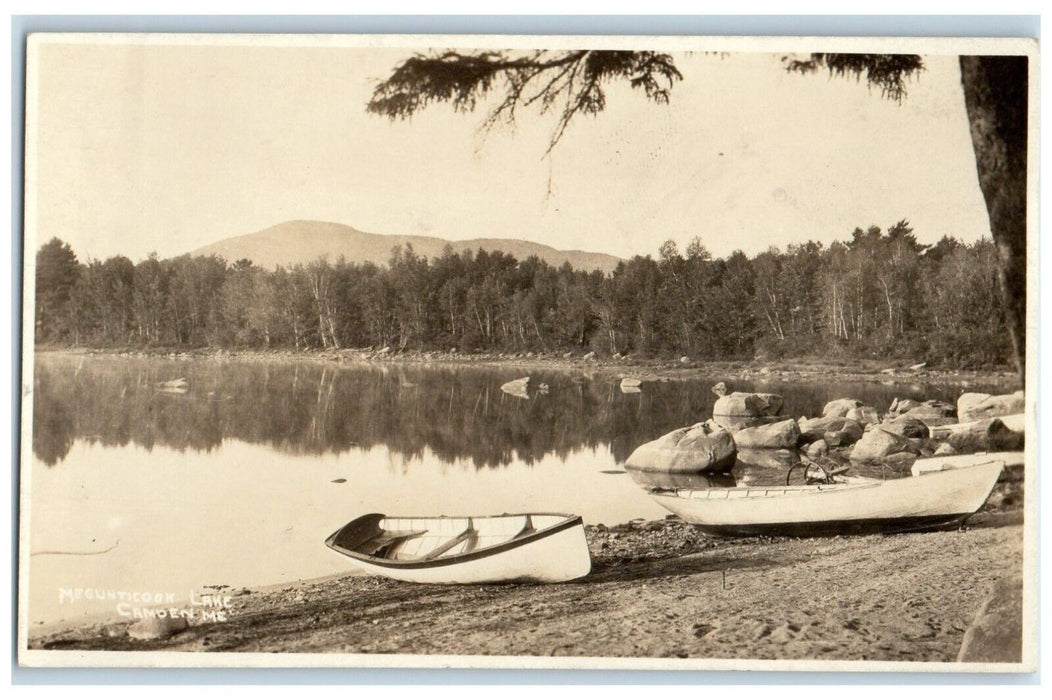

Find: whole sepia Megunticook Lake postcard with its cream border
[18,34,1038,672]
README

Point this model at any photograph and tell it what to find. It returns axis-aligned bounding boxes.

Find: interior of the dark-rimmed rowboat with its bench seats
[331,514,566,561]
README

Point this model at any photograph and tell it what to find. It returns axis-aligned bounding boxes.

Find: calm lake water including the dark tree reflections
[23,355,1005,625]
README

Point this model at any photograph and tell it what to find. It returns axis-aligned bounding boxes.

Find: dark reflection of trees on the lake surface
[33,356,1001,467]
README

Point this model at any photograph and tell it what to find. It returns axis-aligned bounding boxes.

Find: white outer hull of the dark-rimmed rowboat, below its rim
[329,517,591,584]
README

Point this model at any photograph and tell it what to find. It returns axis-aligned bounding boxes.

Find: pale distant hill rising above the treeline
[190,221,621,273]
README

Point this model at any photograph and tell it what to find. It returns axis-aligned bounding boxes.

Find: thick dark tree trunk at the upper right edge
[960,56,1028,382]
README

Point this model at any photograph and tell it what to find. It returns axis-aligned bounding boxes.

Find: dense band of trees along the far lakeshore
[36,220,1011,367]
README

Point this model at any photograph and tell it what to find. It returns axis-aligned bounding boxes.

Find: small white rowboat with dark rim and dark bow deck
[325,513,591,583]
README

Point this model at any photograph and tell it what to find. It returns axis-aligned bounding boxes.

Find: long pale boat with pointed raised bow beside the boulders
[650,460,1004,537]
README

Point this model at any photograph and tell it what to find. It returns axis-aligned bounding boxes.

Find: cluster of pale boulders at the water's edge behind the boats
[626,382,1024,474]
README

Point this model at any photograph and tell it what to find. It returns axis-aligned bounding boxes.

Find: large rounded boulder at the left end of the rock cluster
[625,421,737,473]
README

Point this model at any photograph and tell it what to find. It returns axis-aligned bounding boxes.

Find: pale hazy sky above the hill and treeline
[27,38,989,260]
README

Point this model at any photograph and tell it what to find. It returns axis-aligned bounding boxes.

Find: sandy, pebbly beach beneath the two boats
[29,484,1024,661]
